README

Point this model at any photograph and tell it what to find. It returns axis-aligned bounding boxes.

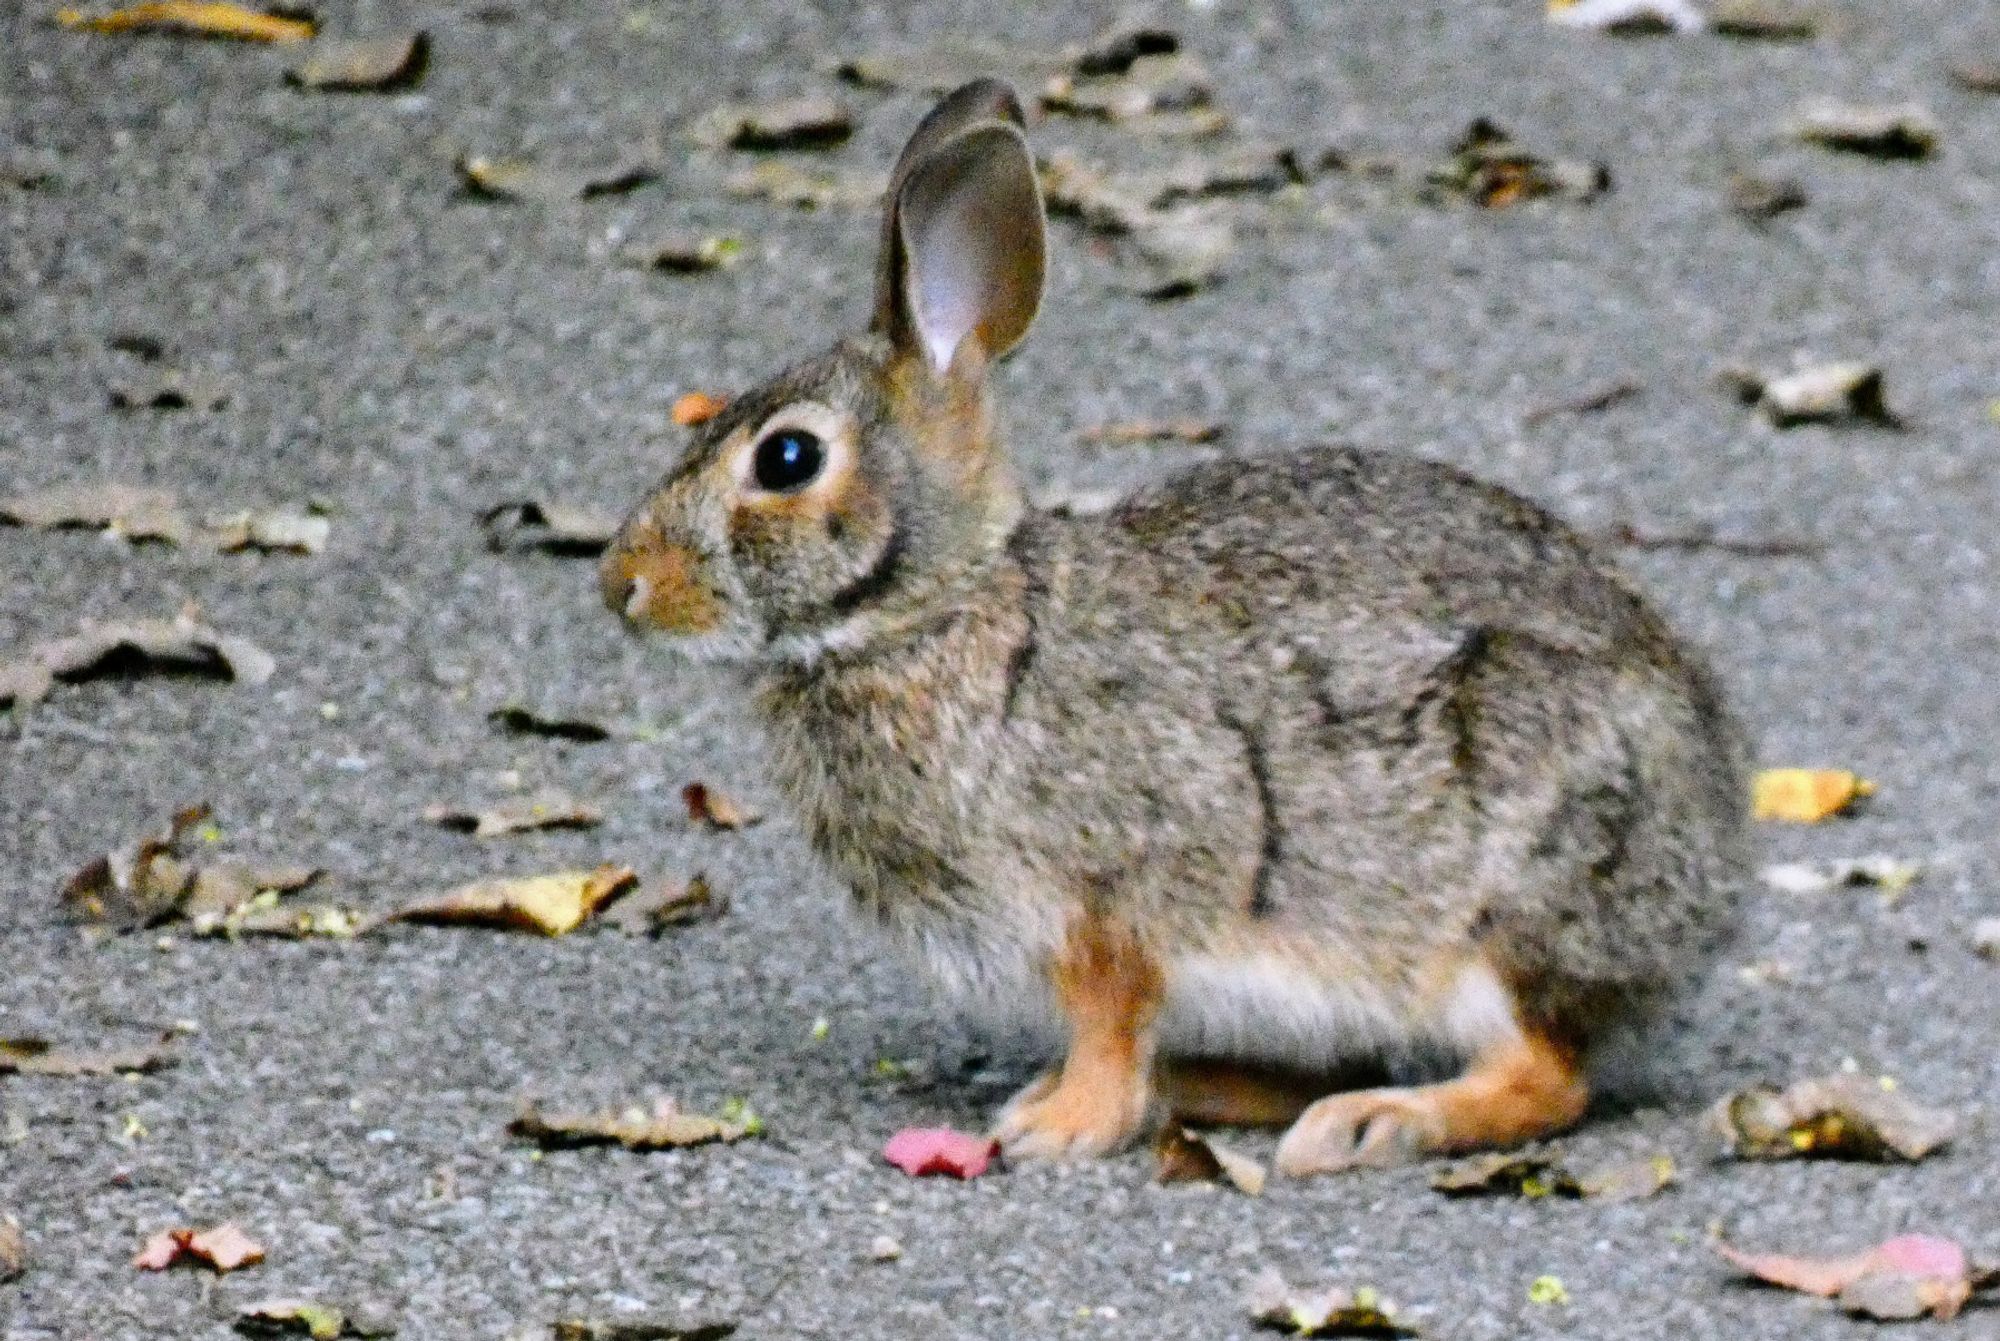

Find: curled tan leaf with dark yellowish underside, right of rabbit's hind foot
[1710,1075,1958,1161]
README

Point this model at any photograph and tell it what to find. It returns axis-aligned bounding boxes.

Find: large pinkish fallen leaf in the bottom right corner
[1716,1233,1984,1321]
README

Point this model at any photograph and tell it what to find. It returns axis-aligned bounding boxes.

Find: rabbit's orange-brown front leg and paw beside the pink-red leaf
[994,913,1162,1159]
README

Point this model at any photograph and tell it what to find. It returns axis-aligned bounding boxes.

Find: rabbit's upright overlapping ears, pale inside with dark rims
[876,80,1046,372]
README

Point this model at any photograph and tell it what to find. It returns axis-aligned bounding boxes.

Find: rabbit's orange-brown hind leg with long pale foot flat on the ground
[1278,1031,1590,1177]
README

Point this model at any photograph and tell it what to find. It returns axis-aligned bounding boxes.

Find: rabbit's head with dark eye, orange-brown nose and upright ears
[602,80,1044,660]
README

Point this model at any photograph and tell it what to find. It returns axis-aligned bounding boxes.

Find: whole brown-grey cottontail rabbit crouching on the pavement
[600,80,1748,1175]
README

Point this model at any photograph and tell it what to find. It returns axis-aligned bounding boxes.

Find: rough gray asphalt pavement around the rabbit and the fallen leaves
[0,0,2000,1341]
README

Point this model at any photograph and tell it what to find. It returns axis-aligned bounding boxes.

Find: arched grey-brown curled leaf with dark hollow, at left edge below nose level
[0,612,276,709]
